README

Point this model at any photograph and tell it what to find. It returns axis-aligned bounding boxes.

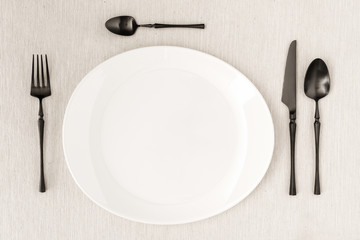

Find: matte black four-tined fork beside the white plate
[30,55,51,192]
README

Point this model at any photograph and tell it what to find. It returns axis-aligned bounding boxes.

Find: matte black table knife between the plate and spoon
[281,40,296,195]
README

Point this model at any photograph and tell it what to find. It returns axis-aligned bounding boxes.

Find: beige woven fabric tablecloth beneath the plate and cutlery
[0,0,360,240]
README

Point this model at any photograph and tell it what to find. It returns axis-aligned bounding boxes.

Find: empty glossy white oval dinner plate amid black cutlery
[63,46,274,224]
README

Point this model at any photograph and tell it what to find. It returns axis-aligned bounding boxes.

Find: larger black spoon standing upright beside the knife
[304,58,330,195]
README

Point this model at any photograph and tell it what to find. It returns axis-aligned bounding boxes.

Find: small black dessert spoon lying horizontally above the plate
[105,16,205,36]
